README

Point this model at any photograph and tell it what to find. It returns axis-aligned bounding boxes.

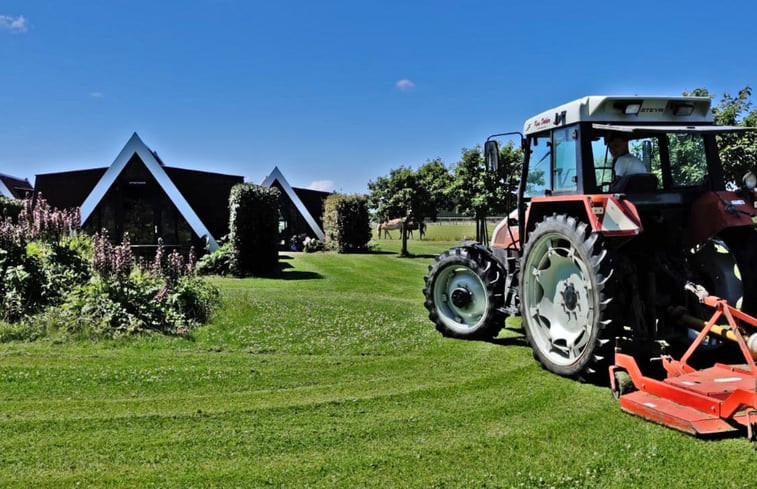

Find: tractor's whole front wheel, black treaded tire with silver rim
[423,247,505,340]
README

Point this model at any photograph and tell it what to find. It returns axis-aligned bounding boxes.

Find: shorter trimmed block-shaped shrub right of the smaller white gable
[323,194,371,253]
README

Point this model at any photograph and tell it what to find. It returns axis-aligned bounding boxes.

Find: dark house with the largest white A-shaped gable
[35,133,243,251]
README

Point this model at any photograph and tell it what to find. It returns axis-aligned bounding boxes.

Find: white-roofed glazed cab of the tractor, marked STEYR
[524,96,744,197]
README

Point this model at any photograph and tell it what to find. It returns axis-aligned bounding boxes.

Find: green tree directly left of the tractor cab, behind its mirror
[449,142,522,242]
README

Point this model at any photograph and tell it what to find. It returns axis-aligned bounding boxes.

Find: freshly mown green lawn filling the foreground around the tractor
[0,235,757,488]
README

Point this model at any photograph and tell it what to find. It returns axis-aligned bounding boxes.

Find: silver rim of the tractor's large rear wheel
[524,233,595,366]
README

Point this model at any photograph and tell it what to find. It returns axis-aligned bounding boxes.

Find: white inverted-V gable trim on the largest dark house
[81,132,218,252]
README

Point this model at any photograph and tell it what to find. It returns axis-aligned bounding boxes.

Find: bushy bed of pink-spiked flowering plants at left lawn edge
[0,197,219,341]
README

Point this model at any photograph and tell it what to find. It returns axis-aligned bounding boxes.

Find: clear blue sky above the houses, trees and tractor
[0,0,757,193]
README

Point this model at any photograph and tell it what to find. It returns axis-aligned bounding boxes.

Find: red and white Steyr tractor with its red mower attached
[424,96,757,435]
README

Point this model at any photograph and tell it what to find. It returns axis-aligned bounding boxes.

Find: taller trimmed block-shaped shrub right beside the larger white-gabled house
[229,183,280,277]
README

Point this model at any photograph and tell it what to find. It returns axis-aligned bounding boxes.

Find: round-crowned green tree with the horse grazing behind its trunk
[368,159,452,256]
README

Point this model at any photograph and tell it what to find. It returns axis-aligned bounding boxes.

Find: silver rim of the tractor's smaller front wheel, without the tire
[434,265,488,333]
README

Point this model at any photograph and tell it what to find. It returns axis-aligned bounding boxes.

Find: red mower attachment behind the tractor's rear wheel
[610,284,757,440]
